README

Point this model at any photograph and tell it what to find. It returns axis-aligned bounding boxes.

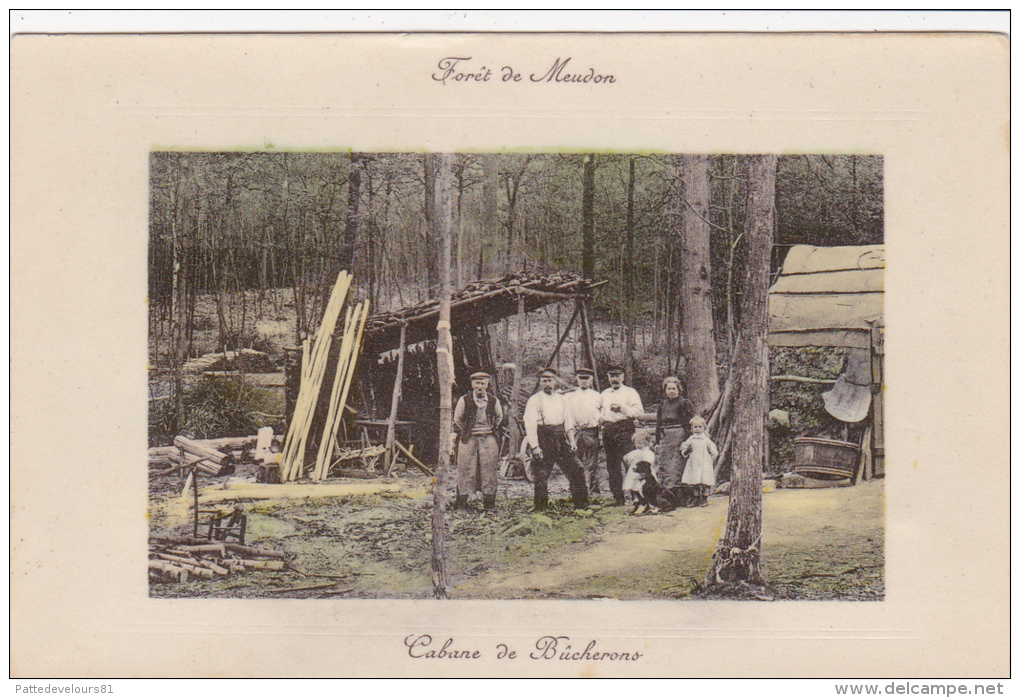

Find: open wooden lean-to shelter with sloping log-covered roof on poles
[361,272,605,472]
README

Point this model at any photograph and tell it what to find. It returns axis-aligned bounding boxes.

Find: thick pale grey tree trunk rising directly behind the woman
[676,155,719,411]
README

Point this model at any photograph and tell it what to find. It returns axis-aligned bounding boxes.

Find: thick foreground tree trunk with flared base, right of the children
[705,155,776,594]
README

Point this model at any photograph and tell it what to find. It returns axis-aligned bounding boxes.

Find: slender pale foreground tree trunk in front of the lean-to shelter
[430,155,456,599]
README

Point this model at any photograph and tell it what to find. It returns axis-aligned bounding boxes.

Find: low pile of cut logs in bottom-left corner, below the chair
[149,538,288,582]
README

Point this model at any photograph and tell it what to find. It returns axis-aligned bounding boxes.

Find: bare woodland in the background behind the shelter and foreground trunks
[149,152,883,432]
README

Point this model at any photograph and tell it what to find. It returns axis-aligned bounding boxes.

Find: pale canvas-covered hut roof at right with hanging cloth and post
[769,245,885,475]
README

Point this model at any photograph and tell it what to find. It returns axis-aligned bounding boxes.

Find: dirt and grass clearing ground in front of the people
[150,465,884,601]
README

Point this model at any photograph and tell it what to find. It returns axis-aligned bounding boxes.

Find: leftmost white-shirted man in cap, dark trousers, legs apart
[524,368,588,511]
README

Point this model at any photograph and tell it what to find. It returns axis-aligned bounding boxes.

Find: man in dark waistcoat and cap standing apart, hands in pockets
[453,371,503,511]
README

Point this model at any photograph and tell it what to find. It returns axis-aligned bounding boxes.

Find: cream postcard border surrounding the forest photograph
[10,34,1009,677]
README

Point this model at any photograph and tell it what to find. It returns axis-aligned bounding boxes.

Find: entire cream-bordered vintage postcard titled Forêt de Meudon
[10,27,1009,678]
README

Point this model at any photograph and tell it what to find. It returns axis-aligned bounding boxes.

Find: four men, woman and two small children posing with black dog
[453,366,718,513]
